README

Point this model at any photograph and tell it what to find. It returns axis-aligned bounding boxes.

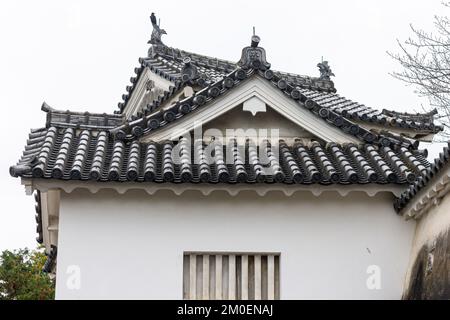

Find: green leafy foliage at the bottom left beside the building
[0,248,55,300]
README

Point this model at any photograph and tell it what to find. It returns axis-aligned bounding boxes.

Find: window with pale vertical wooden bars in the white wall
[183,252,280,300]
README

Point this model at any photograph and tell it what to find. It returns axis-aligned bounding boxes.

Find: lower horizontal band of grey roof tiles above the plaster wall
[10,126,429,184]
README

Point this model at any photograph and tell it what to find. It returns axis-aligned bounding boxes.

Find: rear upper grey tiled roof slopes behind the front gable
[119,46,442,133]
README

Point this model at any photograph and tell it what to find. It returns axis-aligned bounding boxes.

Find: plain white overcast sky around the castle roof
[0,0,445,251]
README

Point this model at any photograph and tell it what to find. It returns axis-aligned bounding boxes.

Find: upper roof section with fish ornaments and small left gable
[112,14,442,145]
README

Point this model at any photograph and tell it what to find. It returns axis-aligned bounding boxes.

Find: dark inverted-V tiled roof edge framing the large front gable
[111,68,417,148]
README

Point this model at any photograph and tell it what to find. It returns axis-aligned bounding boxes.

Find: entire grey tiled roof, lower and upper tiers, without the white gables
[10,30,440,189]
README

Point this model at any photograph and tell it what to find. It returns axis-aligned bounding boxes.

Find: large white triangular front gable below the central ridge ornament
[142,75,358,143]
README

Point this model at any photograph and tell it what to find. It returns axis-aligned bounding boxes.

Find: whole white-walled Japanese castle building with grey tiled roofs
[10,14,450,300]
